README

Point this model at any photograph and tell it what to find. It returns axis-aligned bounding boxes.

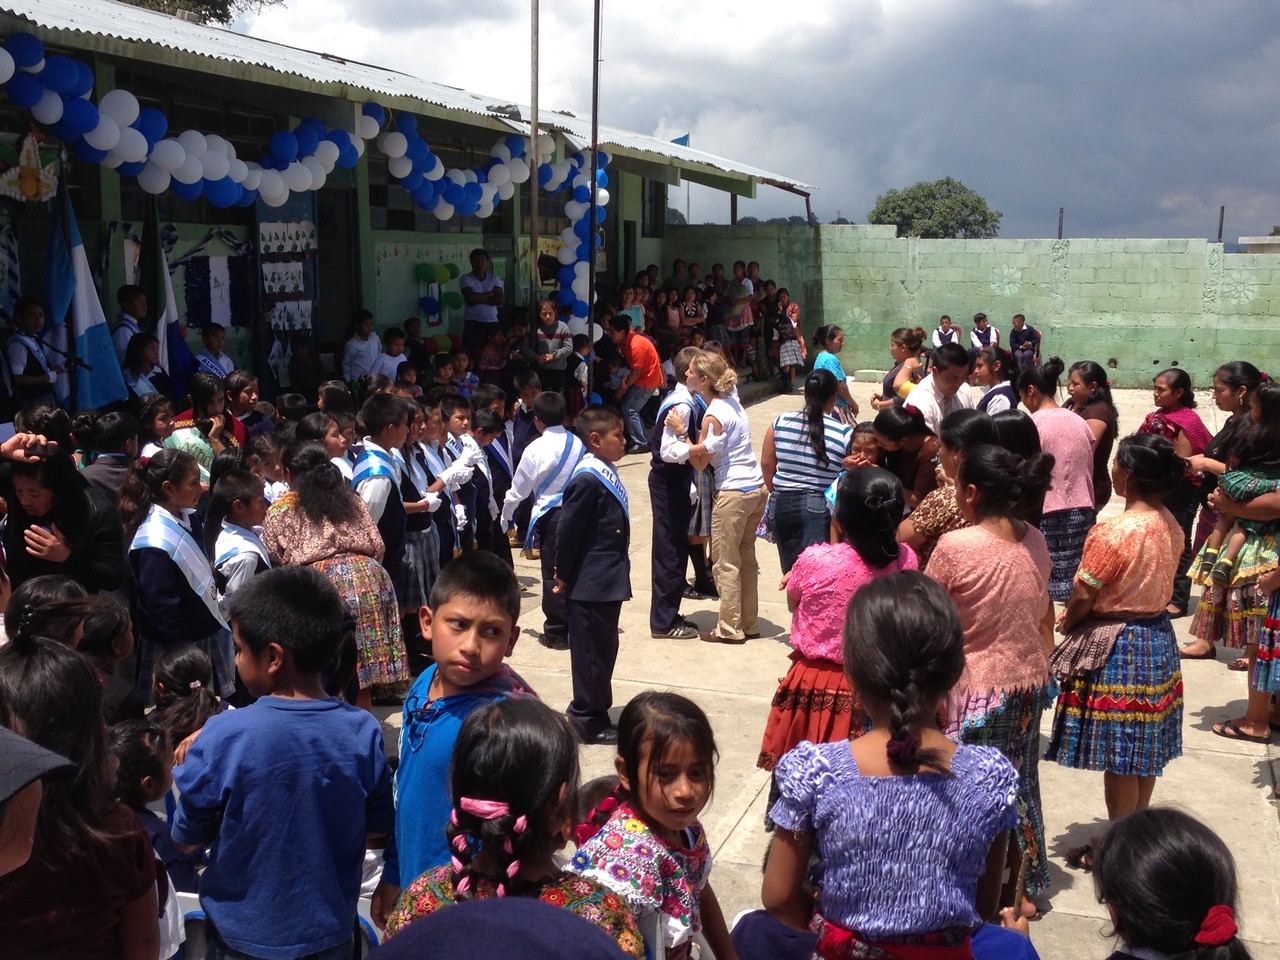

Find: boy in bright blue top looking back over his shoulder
[371,550,535,927]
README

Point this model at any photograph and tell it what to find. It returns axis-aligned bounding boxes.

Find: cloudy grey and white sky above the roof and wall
[237,0,1280,241]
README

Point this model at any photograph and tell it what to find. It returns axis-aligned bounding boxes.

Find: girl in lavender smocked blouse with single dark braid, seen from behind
[762,571,1018,960]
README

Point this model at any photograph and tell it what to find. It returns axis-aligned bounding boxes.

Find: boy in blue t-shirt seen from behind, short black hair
[173,567,394,960]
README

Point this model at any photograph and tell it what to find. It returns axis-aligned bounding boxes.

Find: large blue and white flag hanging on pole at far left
[45,191,129,410]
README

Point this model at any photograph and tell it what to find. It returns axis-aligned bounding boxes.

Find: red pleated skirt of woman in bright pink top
[755,650,868,771]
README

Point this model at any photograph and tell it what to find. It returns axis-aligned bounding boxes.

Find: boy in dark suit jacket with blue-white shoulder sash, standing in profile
[554,406,631,744]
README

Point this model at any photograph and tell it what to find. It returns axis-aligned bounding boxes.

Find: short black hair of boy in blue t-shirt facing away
[228,567,349,675]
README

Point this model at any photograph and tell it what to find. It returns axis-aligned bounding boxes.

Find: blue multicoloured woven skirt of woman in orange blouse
[1044,614,1183,777]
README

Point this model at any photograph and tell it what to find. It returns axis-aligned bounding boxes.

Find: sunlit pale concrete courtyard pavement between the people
[379,376,1280,960]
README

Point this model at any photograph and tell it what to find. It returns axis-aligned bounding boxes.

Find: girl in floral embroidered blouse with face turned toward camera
[570,690,737,960]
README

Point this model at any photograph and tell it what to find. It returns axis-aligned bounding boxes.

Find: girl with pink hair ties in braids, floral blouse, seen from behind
[387,698,644,957]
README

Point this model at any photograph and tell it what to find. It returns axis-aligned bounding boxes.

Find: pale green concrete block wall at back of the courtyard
[664,225,1280,387]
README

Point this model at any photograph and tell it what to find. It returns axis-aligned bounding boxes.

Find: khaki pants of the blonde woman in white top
[712,486,769,640]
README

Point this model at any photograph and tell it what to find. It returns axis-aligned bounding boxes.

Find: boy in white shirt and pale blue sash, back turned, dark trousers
[502,392,586,650]
